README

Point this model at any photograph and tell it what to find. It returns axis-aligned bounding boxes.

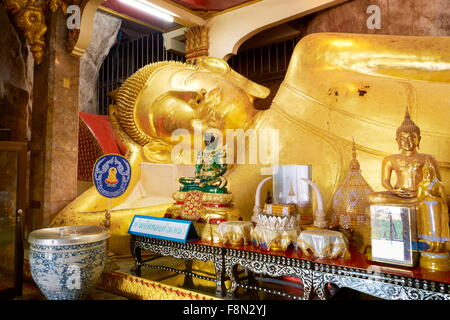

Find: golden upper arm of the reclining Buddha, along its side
[286,33,450,84]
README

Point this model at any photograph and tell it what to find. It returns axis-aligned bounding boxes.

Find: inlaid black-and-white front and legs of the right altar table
[224,248,450,300]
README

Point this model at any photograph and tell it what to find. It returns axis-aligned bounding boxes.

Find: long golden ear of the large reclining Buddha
[196,57,270,99]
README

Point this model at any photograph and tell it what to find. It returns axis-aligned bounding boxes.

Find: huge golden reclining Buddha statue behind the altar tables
[52,33,450,254]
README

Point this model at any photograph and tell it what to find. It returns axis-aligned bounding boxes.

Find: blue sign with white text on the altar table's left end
[128,215,198,242]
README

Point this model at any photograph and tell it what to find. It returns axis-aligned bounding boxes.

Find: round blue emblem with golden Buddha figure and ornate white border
[93,154,131,198]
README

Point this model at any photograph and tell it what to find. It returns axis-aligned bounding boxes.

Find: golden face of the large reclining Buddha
[137,69,256,143]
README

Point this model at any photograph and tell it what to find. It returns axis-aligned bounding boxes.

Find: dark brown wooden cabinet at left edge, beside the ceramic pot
[0,141,27,299]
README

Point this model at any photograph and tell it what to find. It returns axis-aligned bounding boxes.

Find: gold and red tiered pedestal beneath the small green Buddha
[164,190,242,243]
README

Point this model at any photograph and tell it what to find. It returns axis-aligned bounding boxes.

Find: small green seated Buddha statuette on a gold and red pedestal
[179,132,227,193]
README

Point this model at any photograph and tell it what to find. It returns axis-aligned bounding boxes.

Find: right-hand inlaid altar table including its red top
[225,246,450,300]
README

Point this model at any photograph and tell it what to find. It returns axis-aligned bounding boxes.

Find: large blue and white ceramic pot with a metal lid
[28,226,109,300]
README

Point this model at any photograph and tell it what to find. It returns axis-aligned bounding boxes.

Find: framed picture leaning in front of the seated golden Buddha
[370,205,418,267]
